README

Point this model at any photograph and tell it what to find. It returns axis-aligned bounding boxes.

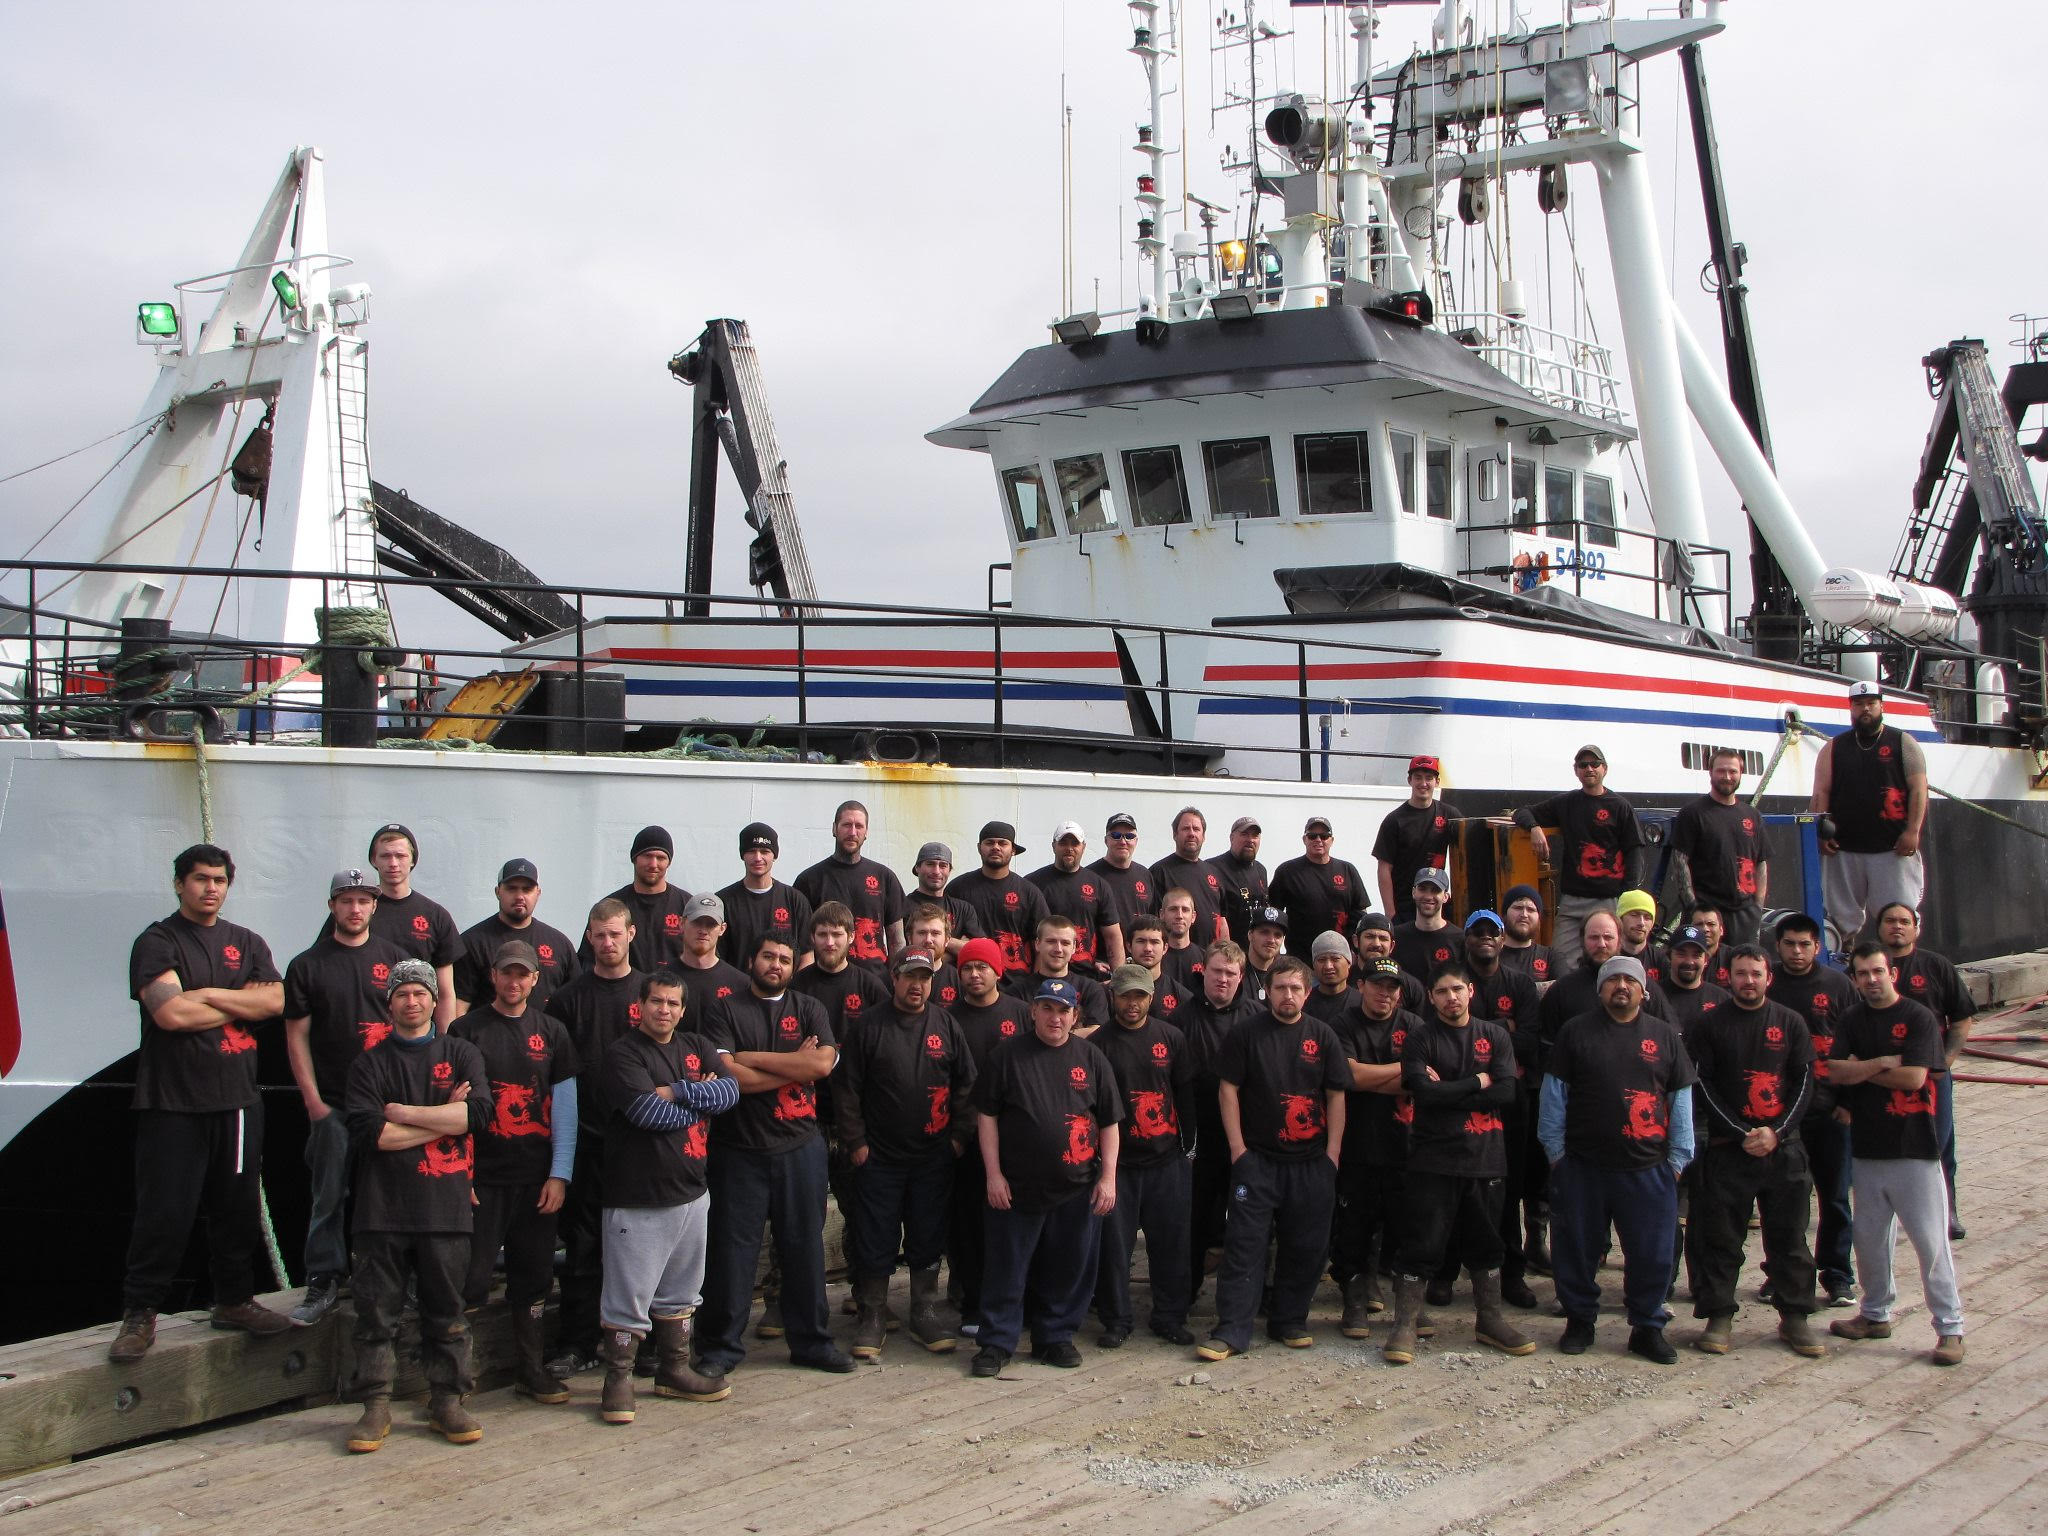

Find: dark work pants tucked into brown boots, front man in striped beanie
[348,1233,477,1401]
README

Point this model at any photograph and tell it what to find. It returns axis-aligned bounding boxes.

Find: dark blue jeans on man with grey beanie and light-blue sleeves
[1550,1153,1677,1327]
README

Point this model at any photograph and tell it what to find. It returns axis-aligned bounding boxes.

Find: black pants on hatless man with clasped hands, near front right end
[1686,1137,1815,1317]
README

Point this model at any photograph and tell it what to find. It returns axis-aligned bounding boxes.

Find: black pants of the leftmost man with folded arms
[121,1100,262,1313]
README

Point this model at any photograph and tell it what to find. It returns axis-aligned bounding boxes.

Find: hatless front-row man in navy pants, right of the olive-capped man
[1196,956,1352,1360]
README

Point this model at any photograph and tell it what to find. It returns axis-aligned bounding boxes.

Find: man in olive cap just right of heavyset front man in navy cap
[1094,965,1196,1350]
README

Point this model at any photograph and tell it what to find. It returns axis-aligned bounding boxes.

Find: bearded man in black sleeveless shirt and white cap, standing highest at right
[1808,682,1927,944]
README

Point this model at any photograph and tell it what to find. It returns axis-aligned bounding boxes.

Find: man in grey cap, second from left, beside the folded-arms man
[285,868,406,1327]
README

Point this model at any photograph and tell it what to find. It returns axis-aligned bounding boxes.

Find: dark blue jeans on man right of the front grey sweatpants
[696,1137,831,1370]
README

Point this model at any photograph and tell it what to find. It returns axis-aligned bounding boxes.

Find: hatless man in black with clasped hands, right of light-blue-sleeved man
[1686,944,1827,1358]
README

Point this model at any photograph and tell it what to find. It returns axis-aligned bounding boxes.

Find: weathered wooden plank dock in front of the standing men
[0,1040,2048,1536]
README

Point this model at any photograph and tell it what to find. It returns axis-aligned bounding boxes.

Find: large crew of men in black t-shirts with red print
[111,684,1968,1452]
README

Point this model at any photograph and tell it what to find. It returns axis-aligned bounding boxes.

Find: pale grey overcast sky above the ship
[0,0,2048,651]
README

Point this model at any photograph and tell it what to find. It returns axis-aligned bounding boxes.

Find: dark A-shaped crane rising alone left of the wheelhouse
[668,319,817,618]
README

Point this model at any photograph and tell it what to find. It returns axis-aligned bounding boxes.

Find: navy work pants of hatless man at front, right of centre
[1214,1149,1337,1352]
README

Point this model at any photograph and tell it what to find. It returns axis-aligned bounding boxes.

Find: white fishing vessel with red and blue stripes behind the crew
[0,0,2048,1325]
